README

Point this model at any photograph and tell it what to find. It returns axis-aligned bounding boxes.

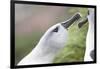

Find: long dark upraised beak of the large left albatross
[61,13,81,29]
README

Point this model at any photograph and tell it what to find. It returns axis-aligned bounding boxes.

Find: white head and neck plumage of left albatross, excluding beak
[19,24,67,65]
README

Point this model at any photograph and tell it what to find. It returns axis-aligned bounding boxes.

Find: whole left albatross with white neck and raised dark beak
[18,13,81,65]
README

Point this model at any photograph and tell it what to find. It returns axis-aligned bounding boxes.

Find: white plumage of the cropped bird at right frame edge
[84,8,94,61]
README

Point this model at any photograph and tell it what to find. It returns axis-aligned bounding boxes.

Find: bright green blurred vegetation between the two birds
[53,8,88,63]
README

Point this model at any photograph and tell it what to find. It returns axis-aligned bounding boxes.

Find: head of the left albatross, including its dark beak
[40,13,81,48]
